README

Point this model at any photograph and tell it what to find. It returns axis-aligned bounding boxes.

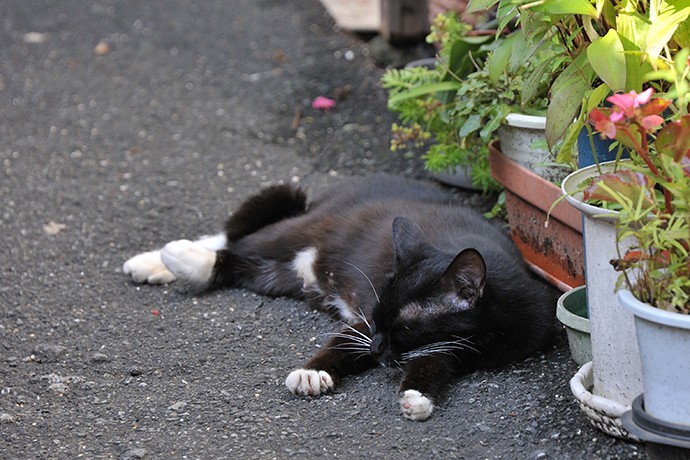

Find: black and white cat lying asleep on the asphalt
[123,176,556,420]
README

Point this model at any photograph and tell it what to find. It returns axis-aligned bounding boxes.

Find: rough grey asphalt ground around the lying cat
[0,0,644,459]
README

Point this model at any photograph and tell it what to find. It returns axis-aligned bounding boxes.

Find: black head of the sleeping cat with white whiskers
[371,217,486,365]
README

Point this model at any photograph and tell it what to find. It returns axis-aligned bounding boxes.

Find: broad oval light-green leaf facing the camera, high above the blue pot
[587,29,626,91]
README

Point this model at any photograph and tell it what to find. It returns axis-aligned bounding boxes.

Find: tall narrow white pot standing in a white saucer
[561,162,642,437]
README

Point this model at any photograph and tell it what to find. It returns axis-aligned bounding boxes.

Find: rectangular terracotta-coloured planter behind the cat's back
[489,142,585,291]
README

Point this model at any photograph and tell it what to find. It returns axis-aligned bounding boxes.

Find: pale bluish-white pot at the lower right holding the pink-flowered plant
[617,290,690,428]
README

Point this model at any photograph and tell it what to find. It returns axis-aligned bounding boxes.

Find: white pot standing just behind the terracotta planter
[498,113,568,183]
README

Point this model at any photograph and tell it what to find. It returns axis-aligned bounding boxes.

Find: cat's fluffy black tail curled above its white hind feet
[225,185,307,241]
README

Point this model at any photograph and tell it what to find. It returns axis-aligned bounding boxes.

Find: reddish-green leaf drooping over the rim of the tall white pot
[584,169,654,207]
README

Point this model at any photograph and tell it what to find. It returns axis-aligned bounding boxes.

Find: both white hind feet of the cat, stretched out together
[122,234,226,284]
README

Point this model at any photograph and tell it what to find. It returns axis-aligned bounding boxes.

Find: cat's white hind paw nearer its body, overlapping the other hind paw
[161,240,216,284]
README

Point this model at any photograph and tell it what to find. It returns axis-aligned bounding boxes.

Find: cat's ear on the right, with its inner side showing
[439,249,486,310]
